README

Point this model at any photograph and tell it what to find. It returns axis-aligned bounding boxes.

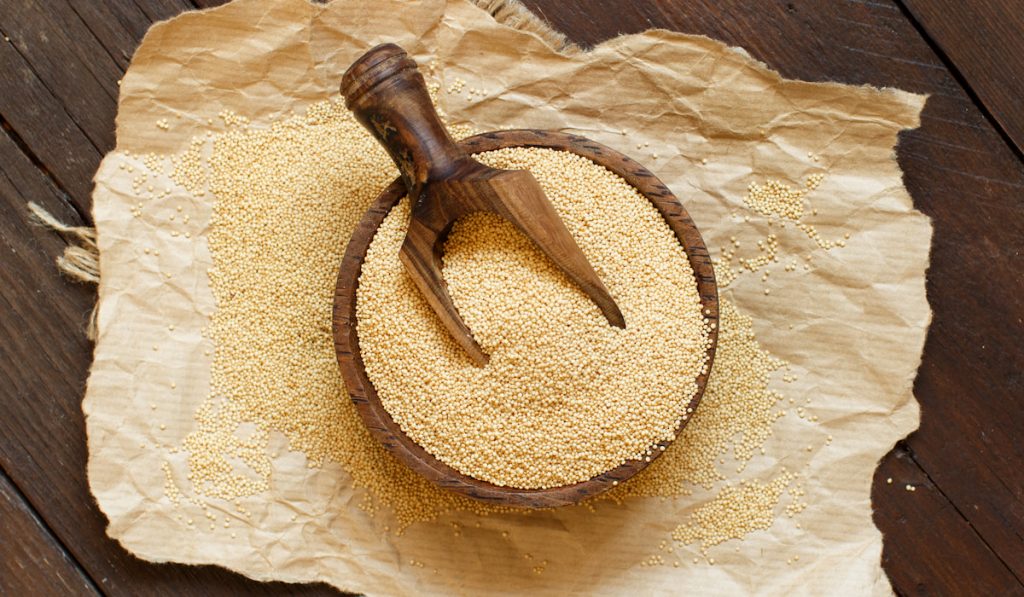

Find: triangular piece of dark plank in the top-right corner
[900,0,1024,158]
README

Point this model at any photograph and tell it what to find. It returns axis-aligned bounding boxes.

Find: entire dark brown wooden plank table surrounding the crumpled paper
[0,0,1024,595]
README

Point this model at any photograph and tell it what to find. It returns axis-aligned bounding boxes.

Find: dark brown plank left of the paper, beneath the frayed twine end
[0,123,334,595]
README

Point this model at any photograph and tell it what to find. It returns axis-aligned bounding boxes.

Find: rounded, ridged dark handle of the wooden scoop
[341,43,467,197]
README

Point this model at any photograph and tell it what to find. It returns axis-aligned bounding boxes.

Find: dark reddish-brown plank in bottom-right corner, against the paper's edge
[871,445,1024,596]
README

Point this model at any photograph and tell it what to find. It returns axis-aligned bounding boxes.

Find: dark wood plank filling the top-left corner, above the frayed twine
[0,0,193,219]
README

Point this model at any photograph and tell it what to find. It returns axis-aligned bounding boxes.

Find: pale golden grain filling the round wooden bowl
[356,147,711,488]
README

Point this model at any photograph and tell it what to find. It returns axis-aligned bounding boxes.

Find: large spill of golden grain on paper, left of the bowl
[173,101,512,526]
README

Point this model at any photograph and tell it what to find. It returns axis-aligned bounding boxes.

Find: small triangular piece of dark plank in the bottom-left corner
[0,473,99,596]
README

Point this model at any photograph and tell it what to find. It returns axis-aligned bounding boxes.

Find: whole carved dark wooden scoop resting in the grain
[341,44,626,367]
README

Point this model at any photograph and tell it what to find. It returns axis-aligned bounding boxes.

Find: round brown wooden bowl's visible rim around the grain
[334,129,718,508]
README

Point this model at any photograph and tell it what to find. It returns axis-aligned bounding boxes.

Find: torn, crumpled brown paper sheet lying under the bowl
[83,0,931,595]
